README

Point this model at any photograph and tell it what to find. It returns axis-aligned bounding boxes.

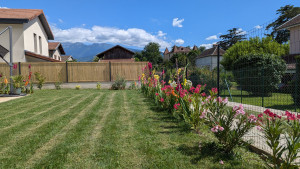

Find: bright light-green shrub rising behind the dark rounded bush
[221,37,289,70]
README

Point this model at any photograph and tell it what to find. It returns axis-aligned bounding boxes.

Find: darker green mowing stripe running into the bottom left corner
[0,94,97,168]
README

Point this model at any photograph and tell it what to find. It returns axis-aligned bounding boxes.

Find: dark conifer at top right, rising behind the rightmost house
[266,5,300,44]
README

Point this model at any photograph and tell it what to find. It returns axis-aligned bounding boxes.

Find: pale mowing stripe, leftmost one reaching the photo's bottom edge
[25,95,102,166]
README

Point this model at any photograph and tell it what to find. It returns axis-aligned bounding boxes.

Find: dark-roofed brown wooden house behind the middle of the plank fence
[96,45,134,62]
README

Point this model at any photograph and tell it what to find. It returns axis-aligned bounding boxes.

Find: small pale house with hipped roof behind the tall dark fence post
[196,44,225,70]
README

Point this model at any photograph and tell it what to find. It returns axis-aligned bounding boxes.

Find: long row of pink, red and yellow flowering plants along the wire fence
[139,63,300,168]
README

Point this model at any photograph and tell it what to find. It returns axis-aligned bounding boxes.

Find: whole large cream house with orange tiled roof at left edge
[0,8,58,62]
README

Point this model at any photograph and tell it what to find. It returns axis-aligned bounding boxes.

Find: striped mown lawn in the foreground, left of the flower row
[0,90,262,169]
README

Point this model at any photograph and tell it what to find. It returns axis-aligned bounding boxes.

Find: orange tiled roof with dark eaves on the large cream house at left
[0,8,54,40]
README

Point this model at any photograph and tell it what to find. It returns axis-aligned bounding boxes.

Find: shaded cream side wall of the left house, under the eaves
[0,24,26,62]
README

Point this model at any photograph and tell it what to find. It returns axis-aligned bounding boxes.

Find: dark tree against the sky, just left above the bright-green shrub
[220,28,246,50]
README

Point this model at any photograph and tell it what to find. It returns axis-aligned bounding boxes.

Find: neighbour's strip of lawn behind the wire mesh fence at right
[221,87,300,112]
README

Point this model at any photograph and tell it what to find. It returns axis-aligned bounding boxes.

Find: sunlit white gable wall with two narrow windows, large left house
[24,17,49,56]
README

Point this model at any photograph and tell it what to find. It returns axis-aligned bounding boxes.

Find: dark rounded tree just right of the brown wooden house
[142,42,163,64]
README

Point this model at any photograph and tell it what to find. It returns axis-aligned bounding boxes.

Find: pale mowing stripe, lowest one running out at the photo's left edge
[0,95,87,154]
